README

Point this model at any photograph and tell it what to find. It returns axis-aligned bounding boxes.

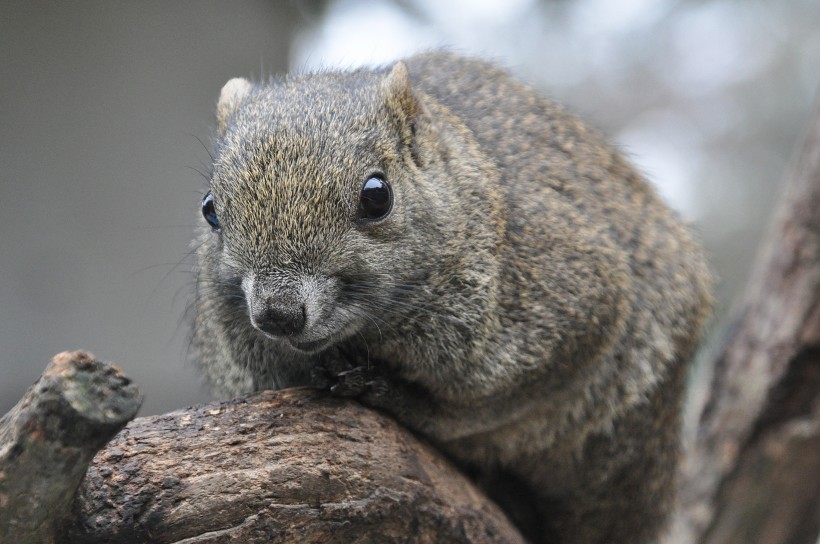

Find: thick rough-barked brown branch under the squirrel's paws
[64,389,522,544]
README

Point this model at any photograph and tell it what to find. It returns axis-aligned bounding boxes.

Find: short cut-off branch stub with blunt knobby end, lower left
[0,352,142,544]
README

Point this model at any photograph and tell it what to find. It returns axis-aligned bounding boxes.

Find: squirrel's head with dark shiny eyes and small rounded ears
[201,62,496,352]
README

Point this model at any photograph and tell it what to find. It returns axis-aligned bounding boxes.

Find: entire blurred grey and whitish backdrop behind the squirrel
[0,0,820,415]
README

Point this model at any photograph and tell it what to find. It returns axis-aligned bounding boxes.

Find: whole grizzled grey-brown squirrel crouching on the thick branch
[192,51,712,544]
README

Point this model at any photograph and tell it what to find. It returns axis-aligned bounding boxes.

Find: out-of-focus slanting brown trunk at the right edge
[669,98,820,544]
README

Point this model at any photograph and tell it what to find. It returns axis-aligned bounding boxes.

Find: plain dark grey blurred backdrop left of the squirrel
[0,0,300,413]
